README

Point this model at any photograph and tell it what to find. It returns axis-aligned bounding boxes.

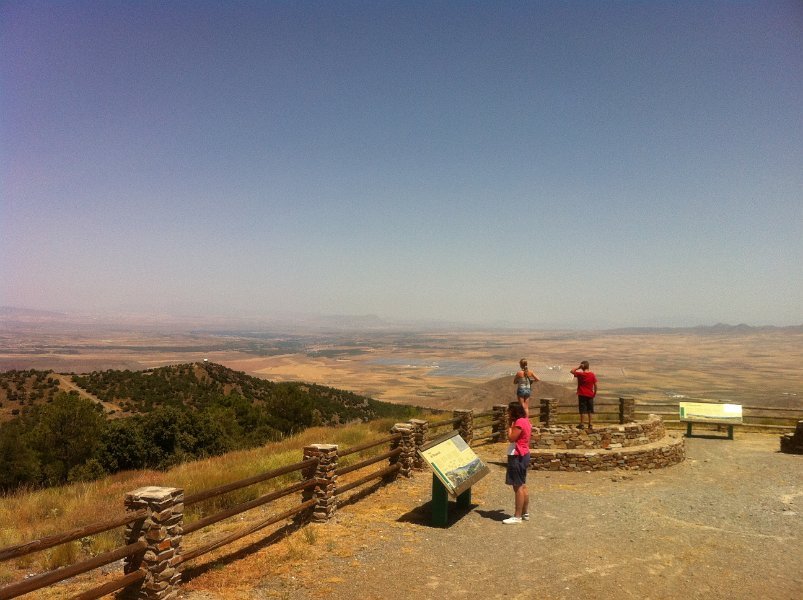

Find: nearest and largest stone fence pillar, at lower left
[117,486,184,600]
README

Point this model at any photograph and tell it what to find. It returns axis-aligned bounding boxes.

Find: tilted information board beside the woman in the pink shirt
[418,431,489,497]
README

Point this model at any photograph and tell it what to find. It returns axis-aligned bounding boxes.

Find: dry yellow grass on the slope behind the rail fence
[0,420,408,583]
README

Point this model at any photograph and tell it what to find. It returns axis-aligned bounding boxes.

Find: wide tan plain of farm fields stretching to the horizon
[0,324,803,407]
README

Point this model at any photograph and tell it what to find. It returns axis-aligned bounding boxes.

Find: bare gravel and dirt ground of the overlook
[181,432,803,600]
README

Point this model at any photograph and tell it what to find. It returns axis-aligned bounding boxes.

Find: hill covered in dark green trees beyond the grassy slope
[0,363,416,490]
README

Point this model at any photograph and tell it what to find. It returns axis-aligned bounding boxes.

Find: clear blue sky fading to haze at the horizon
[0,1,803,328]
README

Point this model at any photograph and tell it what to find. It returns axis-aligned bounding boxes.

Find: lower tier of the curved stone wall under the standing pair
[530,437,686,471]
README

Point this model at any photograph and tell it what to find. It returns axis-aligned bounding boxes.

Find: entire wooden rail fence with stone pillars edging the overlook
[0,398,803,600]
